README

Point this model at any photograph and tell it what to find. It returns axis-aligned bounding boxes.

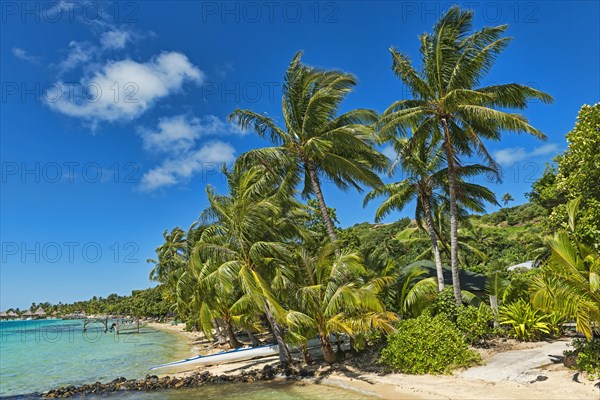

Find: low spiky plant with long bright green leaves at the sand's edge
[498,300,550,342]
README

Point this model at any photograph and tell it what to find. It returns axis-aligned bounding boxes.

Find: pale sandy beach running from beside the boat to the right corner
[149,323,600,400]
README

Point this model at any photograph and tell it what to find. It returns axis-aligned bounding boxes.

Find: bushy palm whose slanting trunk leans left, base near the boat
[196,164,297,364]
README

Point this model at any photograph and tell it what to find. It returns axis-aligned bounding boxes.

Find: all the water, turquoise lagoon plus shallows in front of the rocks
[0,320,370,400]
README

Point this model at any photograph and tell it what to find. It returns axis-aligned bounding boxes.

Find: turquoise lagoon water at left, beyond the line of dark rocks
[0,320,189,396]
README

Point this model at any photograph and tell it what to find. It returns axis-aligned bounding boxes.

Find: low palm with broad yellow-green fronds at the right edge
[531,198,600,340]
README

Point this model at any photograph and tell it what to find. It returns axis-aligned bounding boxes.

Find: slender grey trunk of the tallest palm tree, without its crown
[442,118,462,306]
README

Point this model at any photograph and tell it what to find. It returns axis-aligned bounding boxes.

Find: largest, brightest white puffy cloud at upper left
[46,52,204,126]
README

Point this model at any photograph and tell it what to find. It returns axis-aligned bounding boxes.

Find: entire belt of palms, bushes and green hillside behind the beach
[21,7,600,376]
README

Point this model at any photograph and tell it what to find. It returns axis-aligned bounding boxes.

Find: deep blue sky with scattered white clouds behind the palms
[0,0,600,309]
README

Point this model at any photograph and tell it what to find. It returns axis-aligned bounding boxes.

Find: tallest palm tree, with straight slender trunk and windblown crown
[380,6,552,304]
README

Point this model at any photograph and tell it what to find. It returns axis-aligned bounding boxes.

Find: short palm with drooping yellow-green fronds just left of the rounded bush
[288,243,396,363]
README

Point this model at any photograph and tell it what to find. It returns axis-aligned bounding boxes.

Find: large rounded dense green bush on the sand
[380,313,481,374]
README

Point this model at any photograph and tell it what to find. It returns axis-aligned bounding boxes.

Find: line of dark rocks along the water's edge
[43,365,318,399]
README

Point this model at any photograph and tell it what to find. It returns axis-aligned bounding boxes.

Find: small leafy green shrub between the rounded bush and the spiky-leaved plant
[456,303,494,344]
